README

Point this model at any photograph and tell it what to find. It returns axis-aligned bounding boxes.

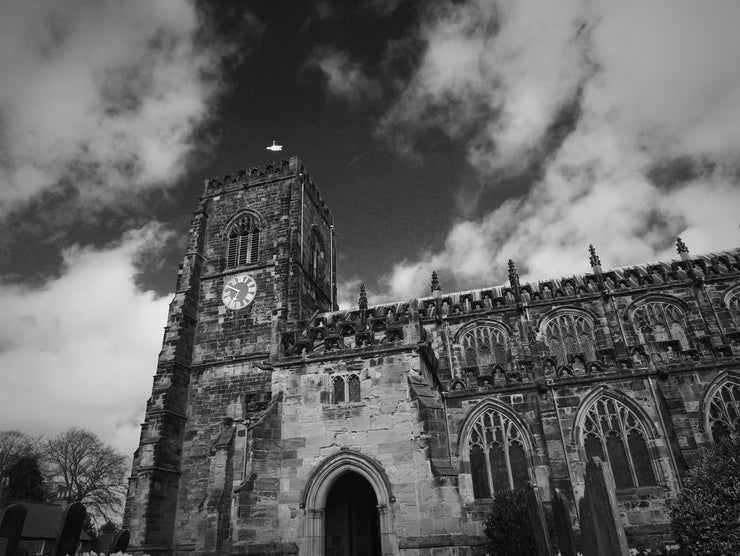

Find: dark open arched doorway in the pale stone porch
[324,471,381,556]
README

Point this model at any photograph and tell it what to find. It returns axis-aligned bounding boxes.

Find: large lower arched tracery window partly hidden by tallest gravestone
[583,396,657,488]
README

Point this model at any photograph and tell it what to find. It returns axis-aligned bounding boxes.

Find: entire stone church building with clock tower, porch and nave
[124,158,740,556]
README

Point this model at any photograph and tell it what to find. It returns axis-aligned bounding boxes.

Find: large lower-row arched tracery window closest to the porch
[468,409,528,499]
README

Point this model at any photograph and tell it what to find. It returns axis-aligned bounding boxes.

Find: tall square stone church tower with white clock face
[124,158,336,554]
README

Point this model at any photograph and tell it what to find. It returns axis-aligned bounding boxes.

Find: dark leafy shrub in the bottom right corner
[670,439,740,556]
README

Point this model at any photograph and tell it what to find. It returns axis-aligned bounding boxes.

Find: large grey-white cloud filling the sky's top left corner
[0,0,255,216]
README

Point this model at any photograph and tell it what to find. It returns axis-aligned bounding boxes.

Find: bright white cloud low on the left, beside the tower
[0,224,169,456]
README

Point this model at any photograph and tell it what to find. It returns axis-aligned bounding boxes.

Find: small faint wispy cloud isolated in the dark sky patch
[308,48,382,103]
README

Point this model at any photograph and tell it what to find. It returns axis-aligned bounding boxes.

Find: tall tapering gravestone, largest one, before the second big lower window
[580,458,629,556]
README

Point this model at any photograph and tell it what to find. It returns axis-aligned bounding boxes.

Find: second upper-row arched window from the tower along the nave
[542,311,596,365]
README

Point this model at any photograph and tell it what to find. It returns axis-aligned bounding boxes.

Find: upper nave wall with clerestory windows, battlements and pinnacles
[417,246,740,392]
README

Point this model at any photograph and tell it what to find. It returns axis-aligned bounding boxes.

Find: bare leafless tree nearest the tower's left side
[41,428,126,521]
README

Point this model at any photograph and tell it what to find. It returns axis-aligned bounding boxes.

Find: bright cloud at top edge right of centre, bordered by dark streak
[382,0,593,173]
